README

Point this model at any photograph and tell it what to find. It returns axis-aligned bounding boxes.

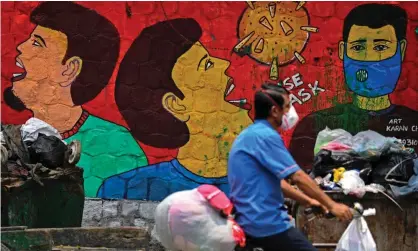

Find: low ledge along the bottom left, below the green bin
[2,227,164,251]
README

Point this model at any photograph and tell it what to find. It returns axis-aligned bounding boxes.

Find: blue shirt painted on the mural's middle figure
[97,159,229,201]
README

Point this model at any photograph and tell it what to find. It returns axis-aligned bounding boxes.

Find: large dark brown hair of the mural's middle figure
[115,18,202,148]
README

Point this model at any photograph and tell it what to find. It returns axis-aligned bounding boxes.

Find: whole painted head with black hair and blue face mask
[339,4,407,98]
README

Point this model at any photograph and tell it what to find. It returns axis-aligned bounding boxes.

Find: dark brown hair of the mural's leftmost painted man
[30,2,120,105]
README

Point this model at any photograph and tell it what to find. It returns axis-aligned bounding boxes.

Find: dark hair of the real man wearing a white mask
[254,83,289,119]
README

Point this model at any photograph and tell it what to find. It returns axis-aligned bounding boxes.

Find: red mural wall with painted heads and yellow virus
[1,1,418,200]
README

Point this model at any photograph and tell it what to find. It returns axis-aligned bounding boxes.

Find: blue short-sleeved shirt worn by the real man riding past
[228,120,300,237]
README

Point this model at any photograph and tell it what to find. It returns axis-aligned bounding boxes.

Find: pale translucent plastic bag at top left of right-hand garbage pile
[314,127,353,154]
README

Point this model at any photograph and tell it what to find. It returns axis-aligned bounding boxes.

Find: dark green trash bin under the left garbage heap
[1,167,84,228]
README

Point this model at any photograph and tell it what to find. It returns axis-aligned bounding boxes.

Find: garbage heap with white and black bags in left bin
[0,118,82,188]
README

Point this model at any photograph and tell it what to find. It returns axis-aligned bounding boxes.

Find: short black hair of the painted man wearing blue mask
[343,3,408,42]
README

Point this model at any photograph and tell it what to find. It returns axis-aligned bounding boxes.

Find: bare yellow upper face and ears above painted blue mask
[339,25,406,61]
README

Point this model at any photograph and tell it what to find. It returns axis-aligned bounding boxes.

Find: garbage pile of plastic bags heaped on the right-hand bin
[310,128,418,198]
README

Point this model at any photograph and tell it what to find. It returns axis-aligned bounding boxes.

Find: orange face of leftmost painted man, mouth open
[12,26,72,109]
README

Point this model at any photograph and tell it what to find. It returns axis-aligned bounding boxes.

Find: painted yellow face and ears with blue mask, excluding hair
[339,25,406,97]
